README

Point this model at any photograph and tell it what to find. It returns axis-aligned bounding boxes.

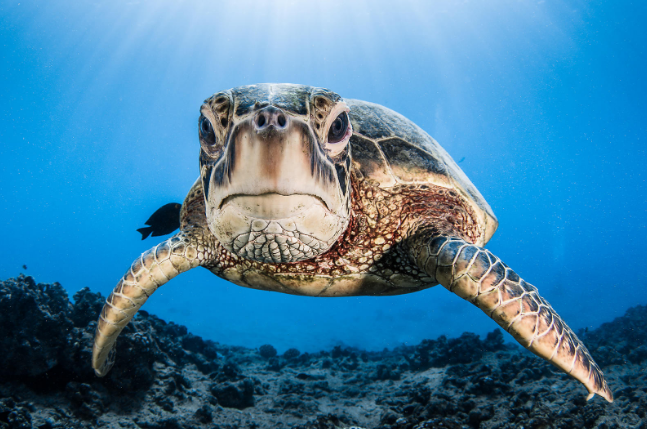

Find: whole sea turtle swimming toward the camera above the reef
[92,84,613,402]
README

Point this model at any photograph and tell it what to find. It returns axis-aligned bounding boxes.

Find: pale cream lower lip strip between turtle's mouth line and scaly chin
[218,192,330,219]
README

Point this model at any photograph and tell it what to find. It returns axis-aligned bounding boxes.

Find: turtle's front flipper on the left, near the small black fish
[92,233,200,377]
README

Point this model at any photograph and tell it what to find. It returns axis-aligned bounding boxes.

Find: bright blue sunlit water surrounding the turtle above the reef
[0,0,647,350]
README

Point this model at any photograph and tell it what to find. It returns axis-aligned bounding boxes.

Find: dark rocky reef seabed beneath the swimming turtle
[0,275,647,429]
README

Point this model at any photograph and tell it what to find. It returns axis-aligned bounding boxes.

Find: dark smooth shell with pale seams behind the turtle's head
[344,100,498,246]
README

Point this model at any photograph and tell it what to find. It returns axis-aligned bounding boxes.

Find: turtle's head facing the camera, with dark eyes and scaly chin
[198,84,352,263]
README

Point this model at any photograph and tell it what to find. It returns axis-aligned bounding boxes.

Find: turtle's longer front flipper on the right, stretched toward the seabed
[410,233,613,402]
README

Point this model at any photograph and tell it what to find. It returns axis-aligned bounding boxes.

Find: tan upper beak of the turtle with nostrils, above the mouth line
[208,106,345,215]
